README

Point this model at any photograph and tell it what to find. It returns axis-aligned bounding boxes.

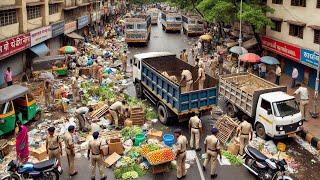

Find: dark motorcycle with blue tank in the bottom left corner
[1,160,62,180]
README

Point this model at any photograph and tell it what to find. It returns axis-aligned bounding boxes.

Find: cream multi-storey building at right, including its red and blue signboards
[262,0,320,87]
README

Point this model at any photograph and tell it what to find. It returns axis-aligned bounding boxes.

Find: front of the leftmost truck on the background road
[125,15,151,44]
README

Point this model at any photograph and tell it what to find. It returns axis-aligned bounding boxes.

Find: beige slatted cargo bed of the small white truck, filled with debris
[219,73,287,117]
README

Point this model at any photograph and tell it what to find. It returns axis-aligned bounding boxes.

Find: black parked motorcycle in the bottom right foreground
[243,145,292,180]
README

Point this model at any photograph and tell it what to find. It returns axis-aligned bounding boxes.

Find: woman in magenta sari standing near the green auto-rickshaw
[16,121,29,163]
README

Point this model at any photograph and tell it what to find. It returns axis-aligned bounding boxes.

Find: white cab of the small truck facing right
[254,91,303,139]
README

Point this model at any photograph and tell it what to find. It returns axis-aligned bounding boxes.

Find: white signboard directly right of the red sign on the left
[30,26,52,47]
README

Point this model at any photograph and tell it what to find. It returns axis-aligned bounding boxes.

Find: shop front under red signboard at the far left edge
[0,33,30,85]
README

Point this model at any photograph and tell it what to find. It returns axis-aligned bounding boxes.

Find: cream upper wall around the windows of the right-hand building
[266,0,320,50]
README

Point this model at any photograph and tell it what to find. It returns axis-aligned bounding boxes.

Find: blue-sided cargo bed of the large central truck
[141,56,218,115]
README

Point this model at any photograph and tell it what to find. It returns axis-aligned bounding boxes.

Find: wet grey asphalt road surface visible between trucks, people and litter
[61,25,254,180]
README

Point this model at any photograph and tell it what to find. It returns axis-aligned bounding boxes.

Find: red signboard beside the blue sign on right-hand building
[262,37,301,62]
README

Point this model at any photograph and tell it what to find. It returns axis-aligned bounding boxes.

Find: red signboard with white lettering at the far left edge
[0,33,30,59]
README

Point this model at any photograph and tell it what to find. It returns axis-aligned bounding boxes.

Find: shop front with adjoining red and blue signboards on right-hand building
[261,37,319,88]
